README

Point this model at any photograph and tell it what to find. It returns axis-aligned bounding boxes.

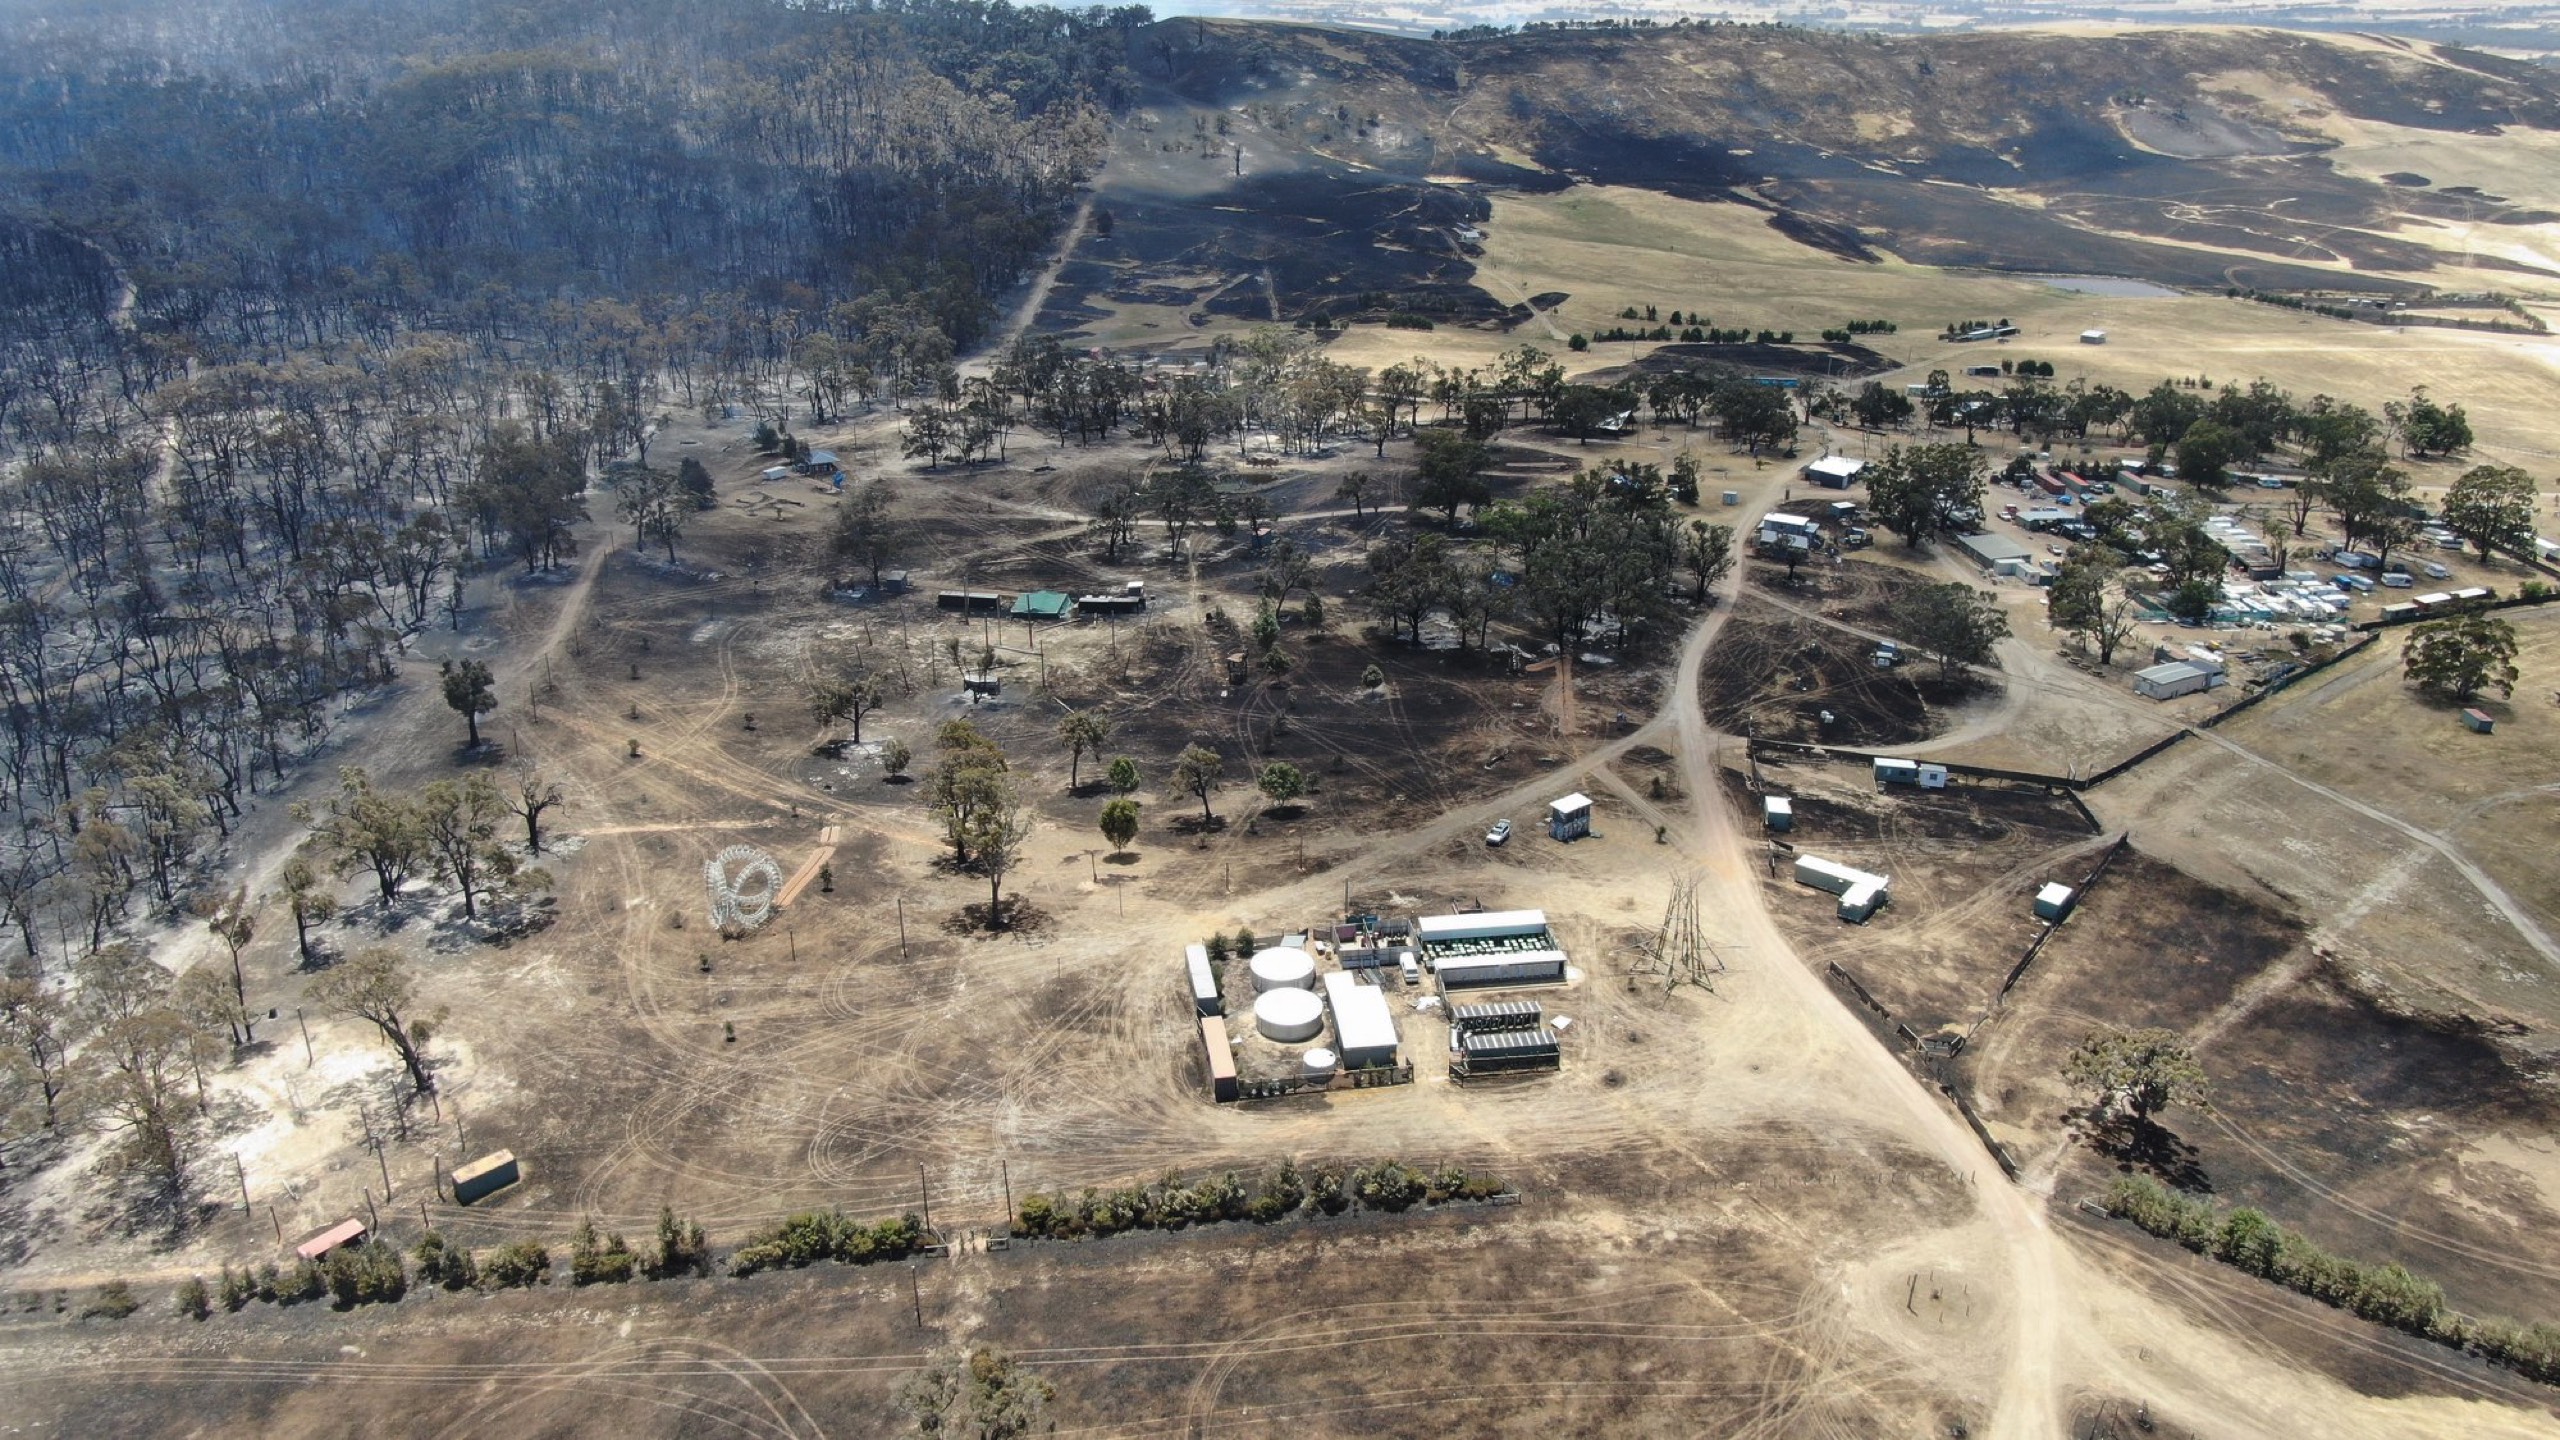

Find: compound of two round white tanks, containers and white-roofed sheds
[1183,910,1572,1102]
